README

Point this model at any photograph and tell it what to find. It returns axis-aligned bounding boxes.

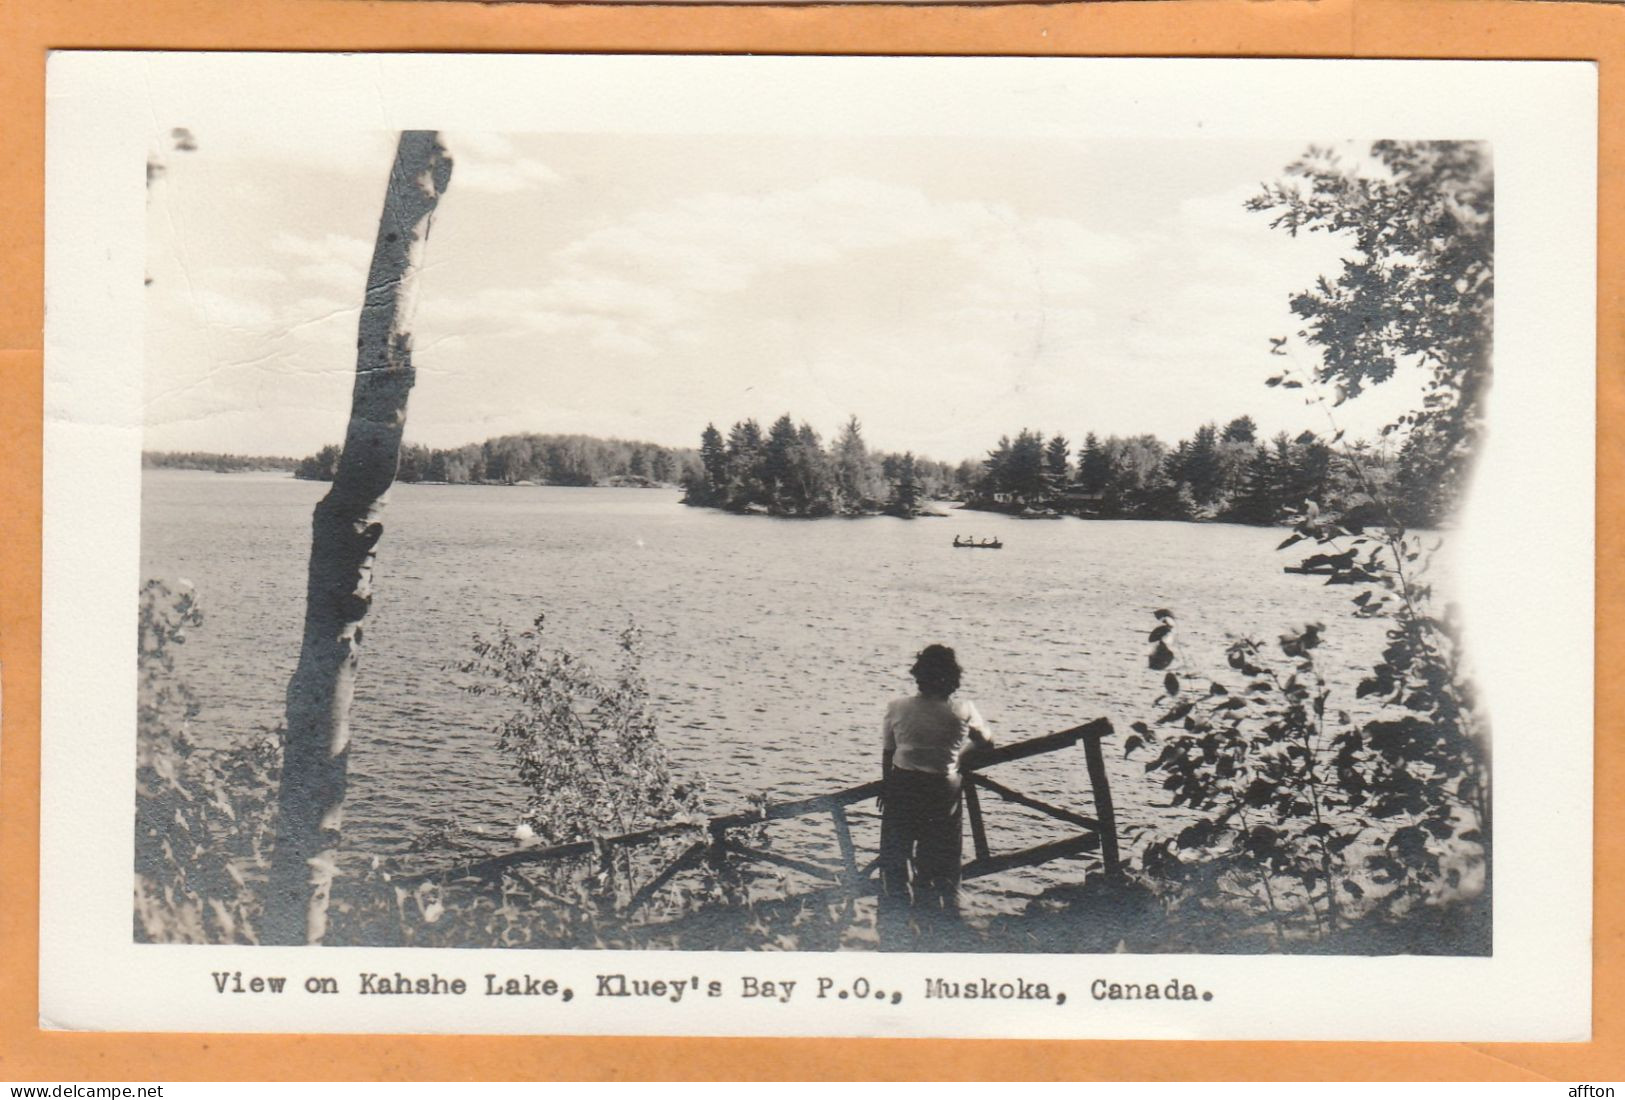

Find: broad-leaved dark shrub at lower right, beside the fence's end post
[1125,507,1490,947]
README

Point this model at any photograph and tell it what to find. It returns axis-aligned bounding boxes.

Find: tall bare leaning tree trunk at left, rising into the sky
[260,130,452,944]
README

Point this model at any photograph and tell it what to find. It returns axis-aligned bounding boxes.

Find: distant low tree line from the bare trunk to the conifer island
[294,432,699,486]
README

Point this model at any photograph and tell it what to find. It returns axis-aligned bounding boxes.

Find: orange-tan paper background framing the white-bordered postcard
[0,0,1625,1082]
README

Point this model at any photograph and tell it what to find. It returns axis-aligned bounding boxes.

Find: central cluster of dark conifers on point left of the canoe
[683,413,973,517]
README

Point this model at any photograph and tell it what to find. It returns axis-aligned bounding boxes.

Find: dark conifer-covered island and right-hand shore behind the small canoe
[683,413,1446,526]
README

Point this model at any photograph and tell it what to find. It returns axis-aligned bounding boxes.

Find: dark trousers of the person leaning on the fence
[879,767,964,939]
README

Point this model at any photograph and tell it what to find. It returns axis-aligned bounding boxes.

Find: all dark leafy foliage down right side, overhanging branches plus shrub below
[1128,141,1493,952]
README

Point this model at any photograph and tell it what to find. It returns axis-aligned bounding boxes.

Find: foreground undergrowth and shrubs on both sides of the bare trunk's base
[135,582,806,949]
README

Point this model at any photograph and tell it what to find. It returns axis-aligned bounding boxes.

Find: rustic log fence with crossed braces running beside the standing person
[397,718,1123,916]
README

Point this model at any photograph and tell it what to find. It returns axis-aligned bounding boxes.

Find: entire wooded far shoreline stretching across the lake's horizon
[161,401,1450,526]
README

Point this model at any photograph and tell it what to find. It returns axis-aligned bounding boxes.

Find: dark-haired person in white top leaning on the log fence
[879,645,993,939]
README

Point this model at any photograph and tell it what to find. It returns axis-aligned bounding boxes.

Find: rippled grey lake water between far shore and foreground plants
[141,470,1410,908]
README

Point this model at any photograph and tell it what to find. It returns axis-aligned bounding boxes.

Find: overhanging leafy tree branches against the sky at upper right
[1246,141,1495,525]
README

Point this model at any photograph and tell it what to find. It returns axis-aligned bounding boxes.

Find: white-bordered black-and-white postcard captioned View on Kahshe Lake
[41,52,1597,1042]
